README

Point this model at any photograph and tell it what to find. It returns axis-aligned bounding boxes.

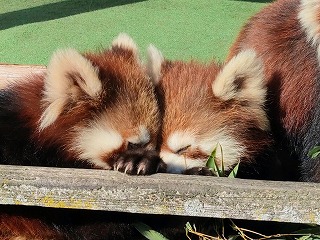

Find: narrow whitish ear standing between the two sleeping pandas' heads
[147,45,164,85]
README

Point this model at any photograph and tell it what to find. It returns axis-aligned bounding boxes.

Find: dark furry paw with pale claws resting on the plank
[113,149,167,175]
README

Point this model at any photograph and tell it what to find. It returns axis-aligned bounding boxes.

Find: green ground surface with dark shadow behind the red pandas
[0,0,270,64]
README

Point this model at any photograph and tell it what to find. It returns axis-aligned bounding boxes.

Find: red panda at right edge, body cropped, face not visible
[229,0,320,182]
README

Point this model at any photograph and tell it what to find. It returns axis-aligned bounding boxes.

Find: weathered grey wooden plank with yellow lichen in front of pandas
[0,165,320,224]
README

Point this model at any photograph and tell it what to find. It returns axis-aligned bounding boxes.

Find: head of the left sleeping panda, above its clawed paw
[31,34,160,172]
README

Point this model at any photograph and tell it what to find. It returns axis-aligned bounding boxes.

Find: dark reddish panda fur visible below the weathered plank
[0,206,216,240]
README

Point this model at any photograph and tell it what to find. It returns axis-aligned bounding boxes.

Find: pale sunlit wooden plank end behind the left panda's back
[0,64,46,89]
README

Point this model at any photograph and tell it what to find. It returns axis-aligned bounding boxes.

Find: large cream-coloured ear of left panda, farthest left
[39,49,102,130]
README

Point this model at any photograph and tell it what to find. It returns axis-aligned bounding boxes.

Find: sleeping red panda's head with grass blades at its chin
[148,46,272,178]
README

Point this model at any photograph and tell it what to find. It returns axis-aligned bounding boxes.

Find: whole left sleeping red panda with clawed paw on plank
[0,34,165,174]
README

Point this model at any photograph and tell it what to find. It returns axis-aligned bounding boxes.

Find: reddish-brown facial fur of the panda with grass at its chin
[158,58,272,177]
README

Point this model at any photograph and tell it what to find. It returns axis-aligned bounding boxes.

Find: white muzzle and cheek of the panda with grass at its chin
[160,129,245,173]
